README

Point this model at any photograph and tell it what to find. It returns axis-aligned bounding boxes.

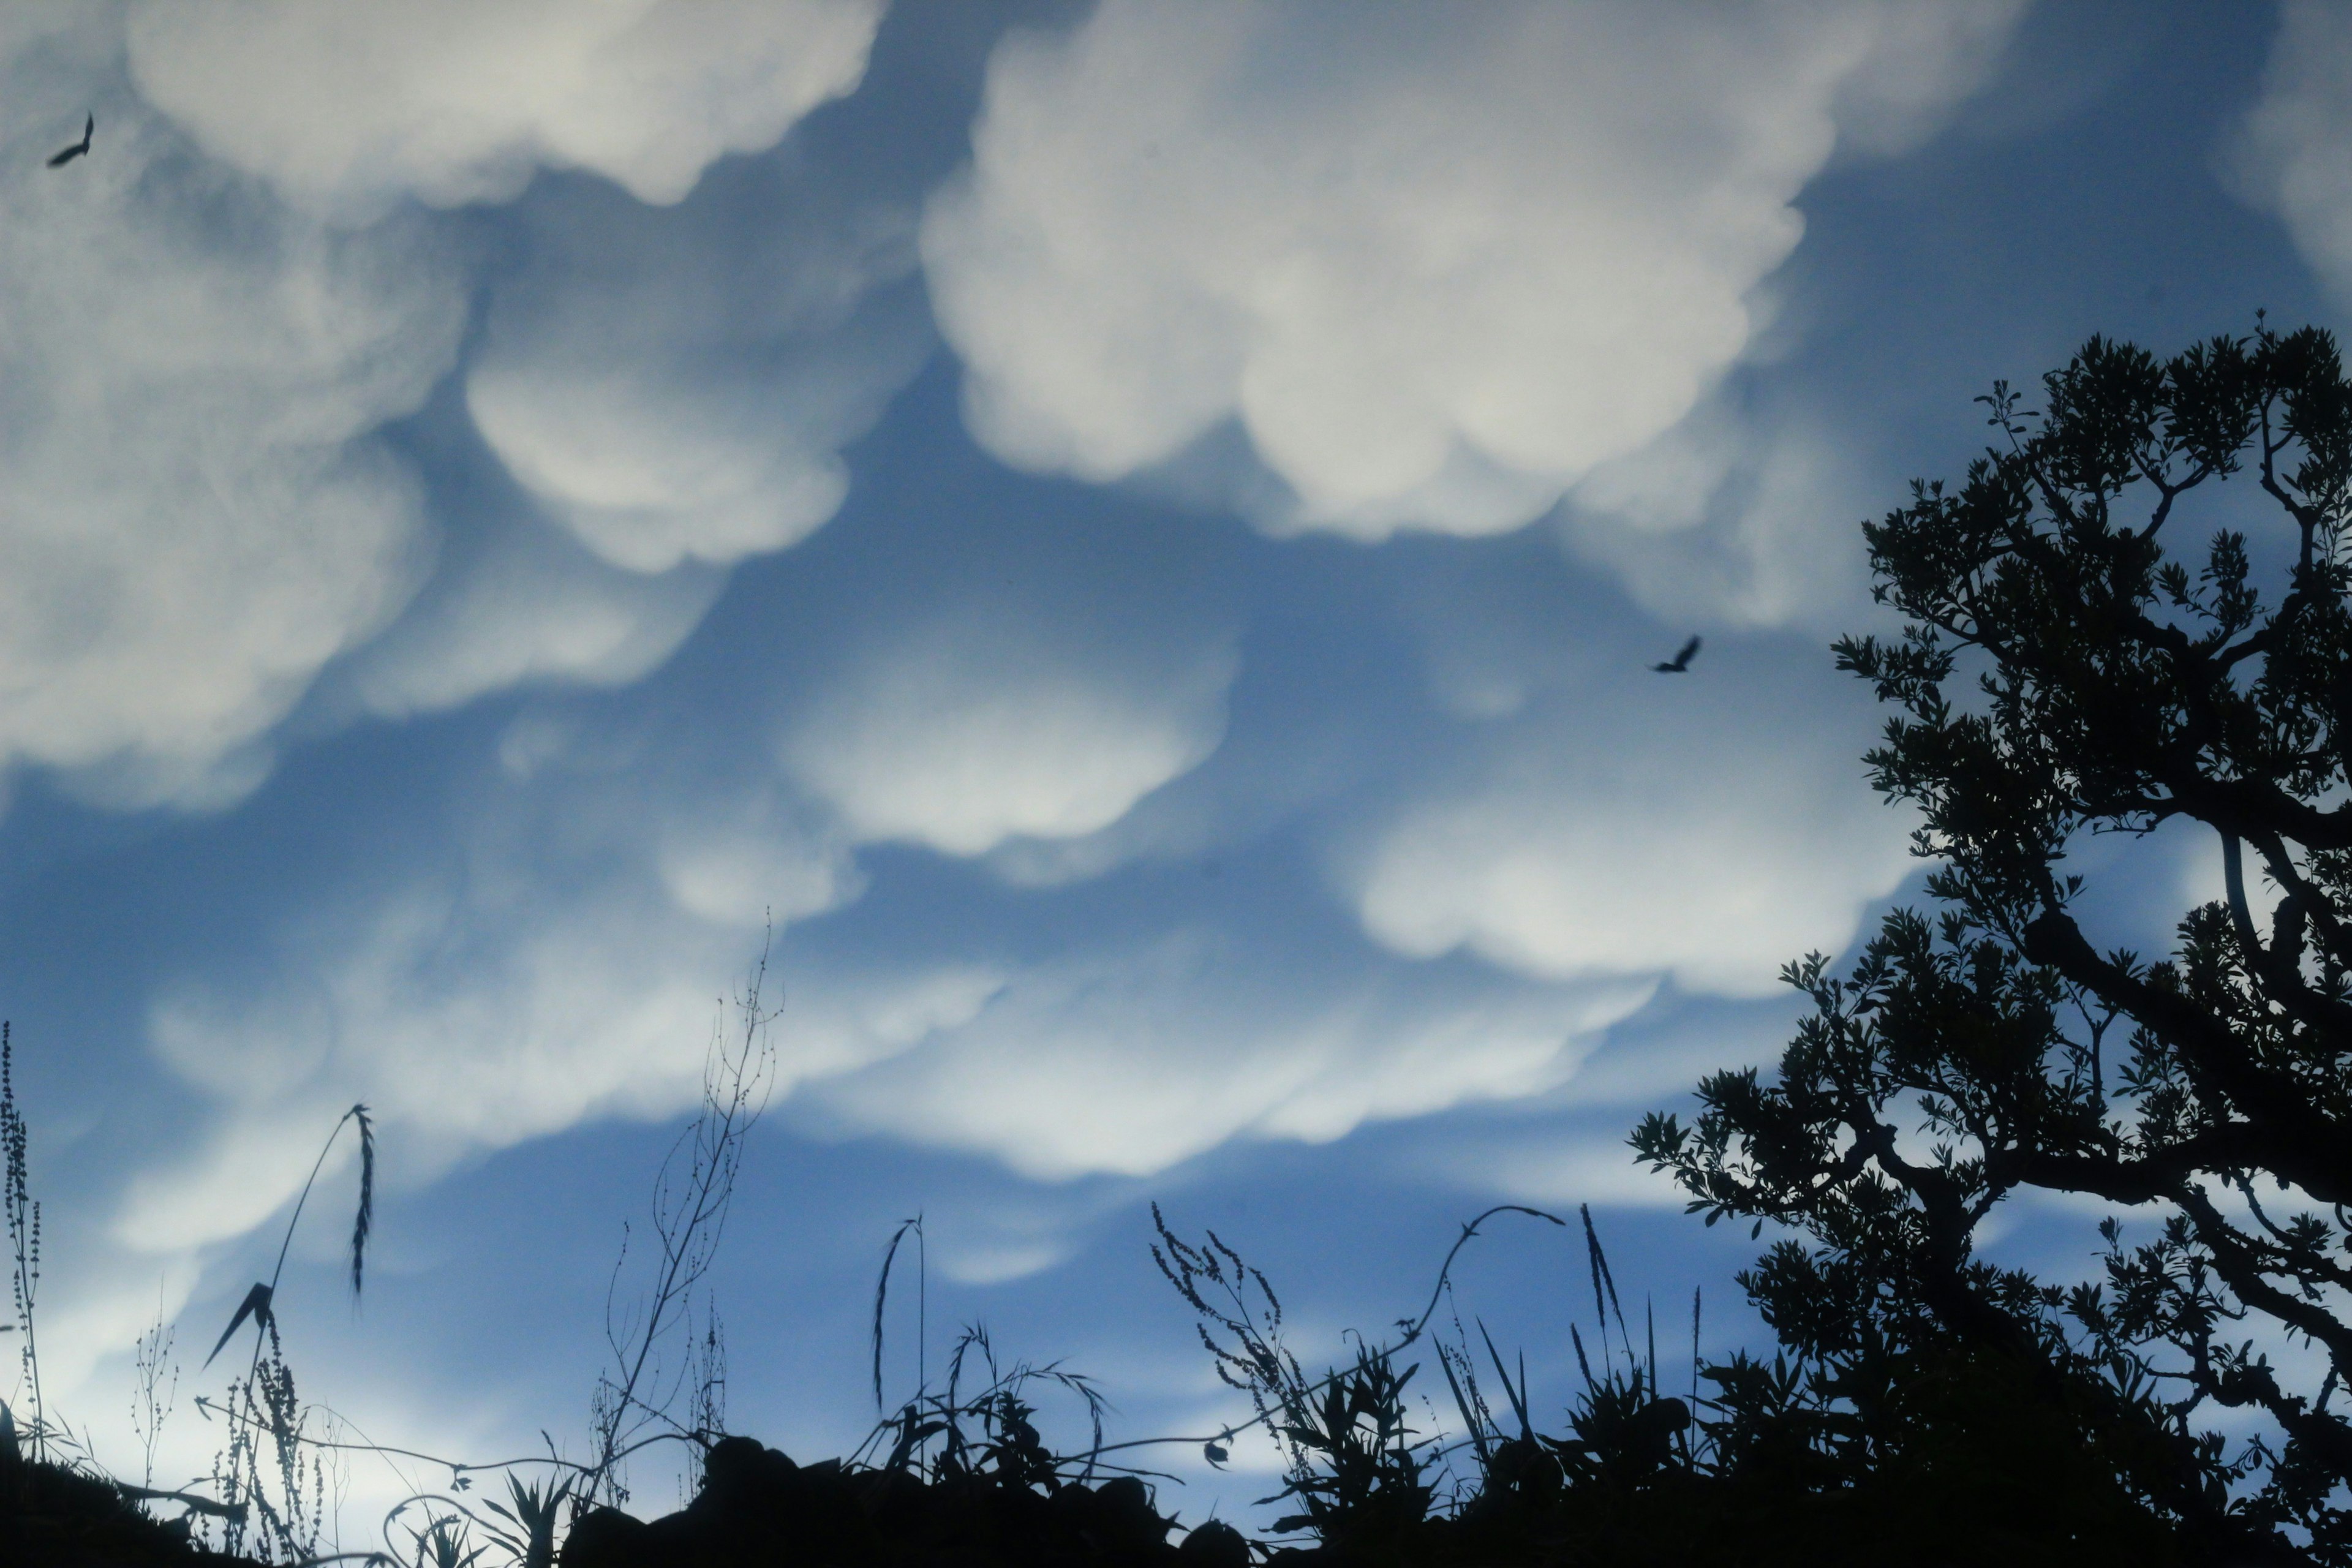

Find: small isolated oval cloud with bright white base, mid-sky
[783,614,1235,856]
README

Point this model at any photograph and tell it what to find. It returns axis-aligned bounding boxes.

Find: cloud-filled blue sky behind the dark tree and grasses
[0,0,2352,1545]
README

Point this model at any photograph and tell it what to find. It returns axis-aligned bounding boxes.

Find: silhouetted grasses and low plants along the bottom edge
[0,987,2183,1568]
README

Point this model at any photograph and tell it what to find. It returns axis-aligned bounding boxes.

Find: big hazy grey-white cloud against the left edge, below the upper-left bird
[0,50,463,804]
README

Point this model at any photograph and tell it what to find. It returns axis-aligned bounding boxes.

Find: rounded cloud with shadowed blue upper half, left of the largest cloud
[466,172,932,573]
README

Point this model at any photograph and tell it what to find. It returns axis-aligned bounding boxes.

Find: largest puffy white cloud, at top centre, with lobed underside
[922,0,2018,538]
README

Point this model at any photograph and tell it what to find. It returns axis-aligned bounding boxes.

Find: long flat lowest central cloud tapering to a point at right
[812,929,1651,1180]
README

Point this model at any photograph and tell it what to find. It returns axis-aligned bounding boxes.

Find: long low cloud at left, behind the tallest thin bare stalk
[115,907,1002,1253]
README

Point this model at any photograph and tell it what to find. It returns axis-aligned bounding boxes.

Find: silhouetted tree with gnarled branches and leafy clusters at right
[1632,322,2352,1563]
